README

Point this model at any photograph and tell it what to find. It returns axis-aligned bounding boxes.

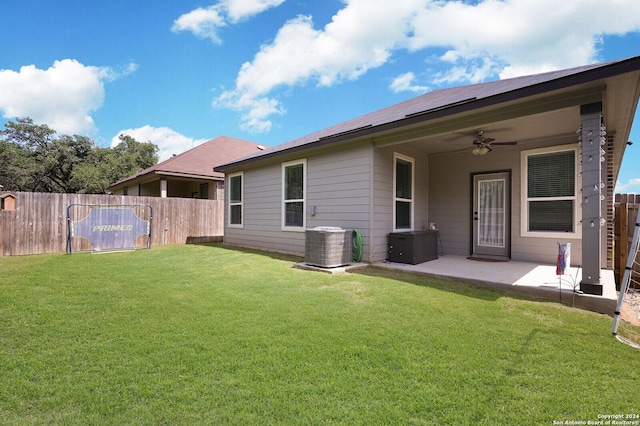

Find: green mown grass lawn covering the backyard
[0,245,640,425]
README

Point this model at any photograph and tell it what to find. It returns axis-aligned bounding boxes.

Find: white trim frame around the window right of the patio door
[520,144,582,239]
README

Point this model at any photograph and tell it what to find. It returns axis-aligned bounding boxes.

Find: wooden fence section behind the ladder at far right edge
[614,194,640,289]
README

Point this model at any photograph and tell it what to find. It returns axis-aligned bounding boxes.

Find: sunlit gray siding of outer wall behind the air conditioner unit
[225,142,371,260]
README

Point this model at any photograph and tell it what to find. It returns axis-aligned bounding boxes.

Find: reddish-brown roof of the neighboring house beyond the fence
[111,136,264,188]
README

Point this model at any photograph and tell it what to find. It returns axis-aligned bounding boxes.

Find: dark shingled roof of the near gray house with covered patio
[216,57,640,171]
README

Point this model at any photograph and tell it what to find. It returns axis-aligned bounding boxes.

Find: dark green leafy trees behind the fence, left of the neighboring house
[0,118,158,194]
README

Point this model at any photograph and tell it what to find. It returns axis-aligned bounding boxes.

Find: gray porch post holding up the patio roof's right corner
[580,102,604,296]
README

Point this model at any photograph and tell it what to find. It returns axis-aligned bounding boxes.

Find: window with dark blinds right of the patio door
[523,147,578,235]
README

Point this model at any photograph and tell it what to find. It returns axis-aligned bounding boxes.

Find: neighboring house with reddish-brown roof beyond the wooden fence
[109,136,262,200]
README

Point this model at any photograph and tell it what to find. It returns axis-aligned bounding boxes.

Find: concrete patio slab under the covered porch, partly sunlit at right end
[373,255,618,316]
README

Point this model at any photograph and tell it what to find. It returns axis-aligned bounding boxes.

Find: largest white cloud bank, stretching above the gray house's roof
[214,0,640,131]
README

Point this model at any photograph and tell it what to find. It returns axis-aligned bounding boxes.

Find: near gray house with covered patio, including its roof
[216,57,640,294]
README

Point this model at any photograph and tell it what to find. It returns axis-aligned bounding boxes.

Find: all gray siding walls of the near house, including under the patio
[225,131,582,265]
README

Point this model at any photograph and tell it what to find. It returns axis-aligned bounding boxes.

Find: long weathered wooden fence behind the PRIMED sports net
[0,192,224,256]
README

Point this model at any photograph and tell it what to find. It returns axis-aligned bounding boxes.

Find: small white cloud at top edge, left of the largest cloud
[171,0,285,44]
